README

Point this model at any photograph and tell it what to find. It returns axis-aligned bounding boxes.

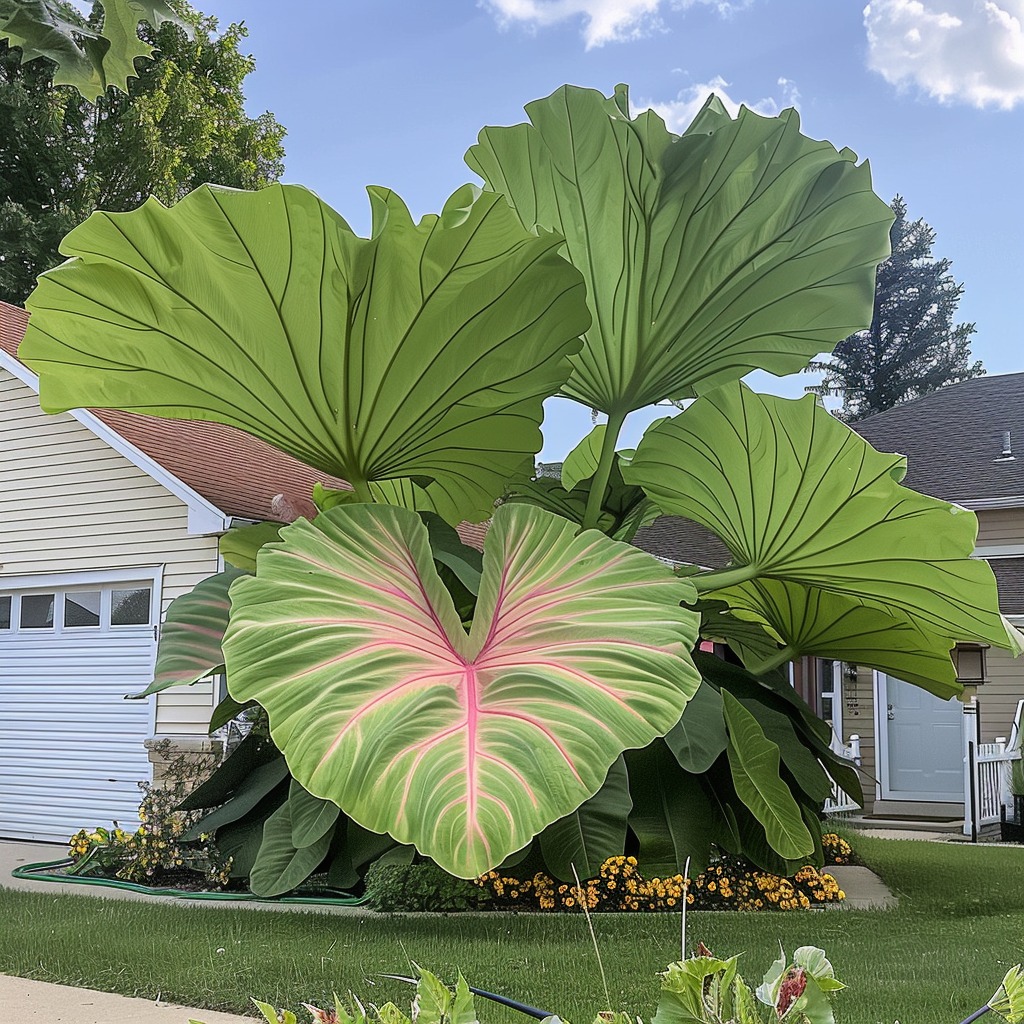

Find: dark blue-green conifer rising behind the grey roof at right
[808,196,985,422]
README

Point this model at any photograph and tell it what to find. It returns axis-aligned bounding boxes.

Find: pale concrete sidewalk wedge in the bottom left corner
[0,974,253,1024]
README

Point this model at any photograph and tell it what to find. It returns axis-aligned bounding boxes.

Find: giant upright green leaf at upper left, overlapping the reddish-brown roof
[20,179,590,523]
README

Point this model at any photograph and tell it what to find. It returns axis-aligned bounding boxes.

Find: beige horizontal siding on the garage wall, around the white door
[0,370,217,735]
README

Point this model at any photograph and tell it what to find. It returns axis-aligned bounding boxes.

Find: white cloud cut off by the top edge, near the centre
[479,0,753,50]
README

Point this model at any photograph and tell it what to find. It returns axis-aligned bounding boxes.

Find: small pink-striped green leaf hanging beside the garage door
[133,568,249,697]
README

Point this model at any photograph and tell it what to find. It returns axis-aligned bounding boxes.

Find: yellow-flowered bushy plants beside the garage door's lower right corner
[68,741,231,889]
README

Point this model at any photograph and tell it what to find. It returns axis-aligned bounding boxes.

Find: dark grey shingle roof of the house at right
[851,373,1024,507]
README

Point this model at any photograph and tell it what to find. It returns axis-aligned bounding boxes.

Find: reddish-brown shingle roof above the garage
[0,302,347,519]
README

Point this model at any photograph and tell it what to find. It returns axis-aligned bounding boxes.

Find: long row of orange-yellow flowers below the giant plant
[476,856,846,910]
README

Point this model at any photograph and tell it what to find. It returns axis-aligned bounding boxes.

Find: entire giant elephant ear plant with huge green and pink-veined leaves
[20,86,1020,894]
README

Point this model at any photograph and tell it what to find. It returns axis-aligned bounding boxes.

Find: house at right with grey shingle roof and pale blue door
[847,373,1024,818]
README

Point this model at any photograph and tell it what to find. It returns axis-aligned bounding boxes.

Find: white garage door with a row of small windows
[0,580,156,842]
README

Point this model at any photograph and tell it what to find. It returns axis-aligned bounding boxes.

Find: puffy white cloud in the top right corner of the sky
[864,0,1024,111]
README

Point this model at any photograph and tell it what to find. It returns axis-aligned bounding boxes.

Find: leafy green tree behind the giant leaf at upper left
[0,2,285,303]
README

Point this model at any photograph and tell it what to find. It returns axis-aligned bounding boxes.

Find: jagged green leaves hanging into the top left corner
[0,0,190,100]
